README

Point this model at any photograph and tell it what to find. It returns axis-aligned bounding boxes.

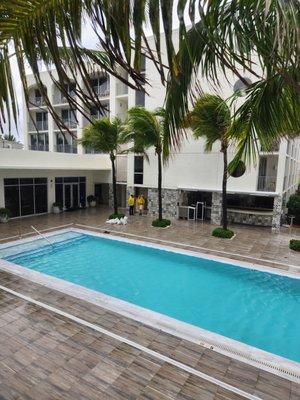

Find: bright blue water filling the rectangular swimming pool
[0,233,300,362]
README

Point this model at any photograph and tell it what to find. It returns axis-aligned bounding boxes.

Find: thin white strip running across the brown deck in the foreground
[0,285,261,400]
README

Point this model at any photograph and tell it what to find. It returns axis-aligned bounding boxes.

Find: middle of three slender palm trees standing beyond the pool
[126,107,169,221]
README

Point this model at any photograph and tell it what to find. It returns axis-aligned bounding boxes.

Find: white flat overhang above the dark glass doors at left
[0,149,111,171]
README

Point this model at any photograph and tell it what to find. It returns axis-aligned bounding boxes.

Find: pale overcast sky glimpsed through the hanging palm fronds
[4,1,195,142]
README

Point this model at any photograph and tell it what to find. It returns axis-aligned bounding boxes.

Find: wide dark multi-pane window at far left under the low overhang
[4,178,48,217]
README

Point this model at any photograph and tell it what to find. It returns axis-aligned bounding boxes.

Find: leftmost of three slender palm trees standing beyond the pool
[78,117,124,218]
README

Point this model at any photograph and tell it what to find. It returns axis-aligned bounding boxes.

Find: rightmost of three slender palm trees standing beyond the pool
[188,94,232,230]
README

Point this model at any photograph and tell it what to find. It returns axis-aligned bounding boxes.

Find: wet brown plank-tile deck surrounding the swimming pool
[0,209,300,400]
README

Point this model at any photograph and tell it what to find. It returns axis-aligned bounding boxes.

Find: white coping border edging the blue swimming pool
[0,228,300,383]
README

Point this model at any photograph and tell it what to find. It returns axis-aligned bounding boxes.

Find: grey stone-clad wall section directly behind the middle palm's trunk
[148,188,179,218]
